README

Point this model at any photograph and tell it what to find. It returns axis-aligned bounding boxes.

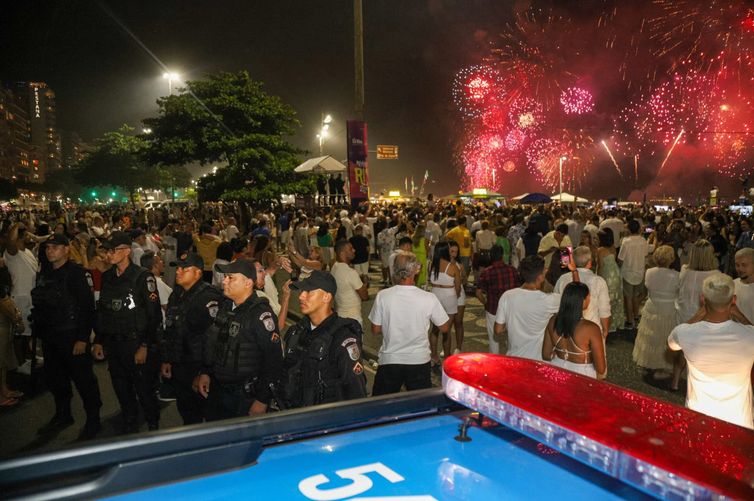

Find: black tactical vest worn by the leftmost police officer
[31,265,81,338]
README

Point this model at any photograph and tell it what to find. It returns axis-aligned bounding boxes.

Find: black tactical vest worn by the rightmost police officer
[284,318,361,407]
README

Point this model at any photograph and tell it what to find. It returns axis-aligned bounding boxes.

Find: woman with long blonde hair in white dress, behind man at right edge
[670,238,718,391]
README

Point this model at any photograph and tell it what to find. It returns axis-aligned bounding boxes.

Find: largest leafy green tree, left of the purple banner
[144,71,312,205]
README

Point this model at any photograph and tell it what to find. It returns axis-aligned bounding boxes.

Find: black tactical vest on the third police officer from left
[163,281,211,362]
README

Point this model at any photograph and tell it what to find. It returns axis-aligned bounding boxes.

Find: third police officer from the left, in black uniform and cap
[161,253,223,424]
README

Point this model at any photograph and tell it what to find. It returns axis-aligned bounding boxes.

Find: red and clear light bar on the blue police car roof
[443,353,754,500]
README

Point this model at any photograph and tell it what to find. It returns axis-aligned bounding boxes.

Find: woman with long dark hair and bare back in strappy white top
[542,282,607,379]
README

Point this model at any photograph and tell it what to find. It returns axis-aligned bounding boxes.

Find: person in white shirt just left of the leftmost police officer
[3,223,39,336]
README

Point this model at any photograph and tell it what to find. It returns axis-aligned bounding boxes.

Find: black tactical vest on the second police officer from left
[97,268,149,338]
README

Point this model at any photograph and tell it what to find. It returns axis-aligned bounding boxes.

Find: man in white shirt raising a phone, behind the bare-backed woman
[553,245,610,337]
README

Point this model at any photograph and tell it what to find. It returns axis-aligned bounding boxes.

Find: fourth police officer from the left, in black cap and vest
[197,259,283,420]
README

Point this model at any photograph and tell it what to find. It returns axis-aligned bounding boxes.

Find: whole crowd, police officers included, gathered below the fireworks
[0,196,754,438]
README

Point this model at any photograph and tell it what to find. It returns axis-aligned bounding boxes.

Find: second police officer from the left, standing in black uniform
[92,231,162,433]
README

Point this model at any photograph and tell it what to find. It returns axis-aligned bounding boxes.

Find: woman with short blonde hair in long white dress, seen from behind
[633,245,680,379]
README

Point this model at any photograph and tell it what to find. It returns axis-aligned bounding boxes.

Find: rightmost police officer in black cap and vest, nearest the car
[283,270,366,407]
